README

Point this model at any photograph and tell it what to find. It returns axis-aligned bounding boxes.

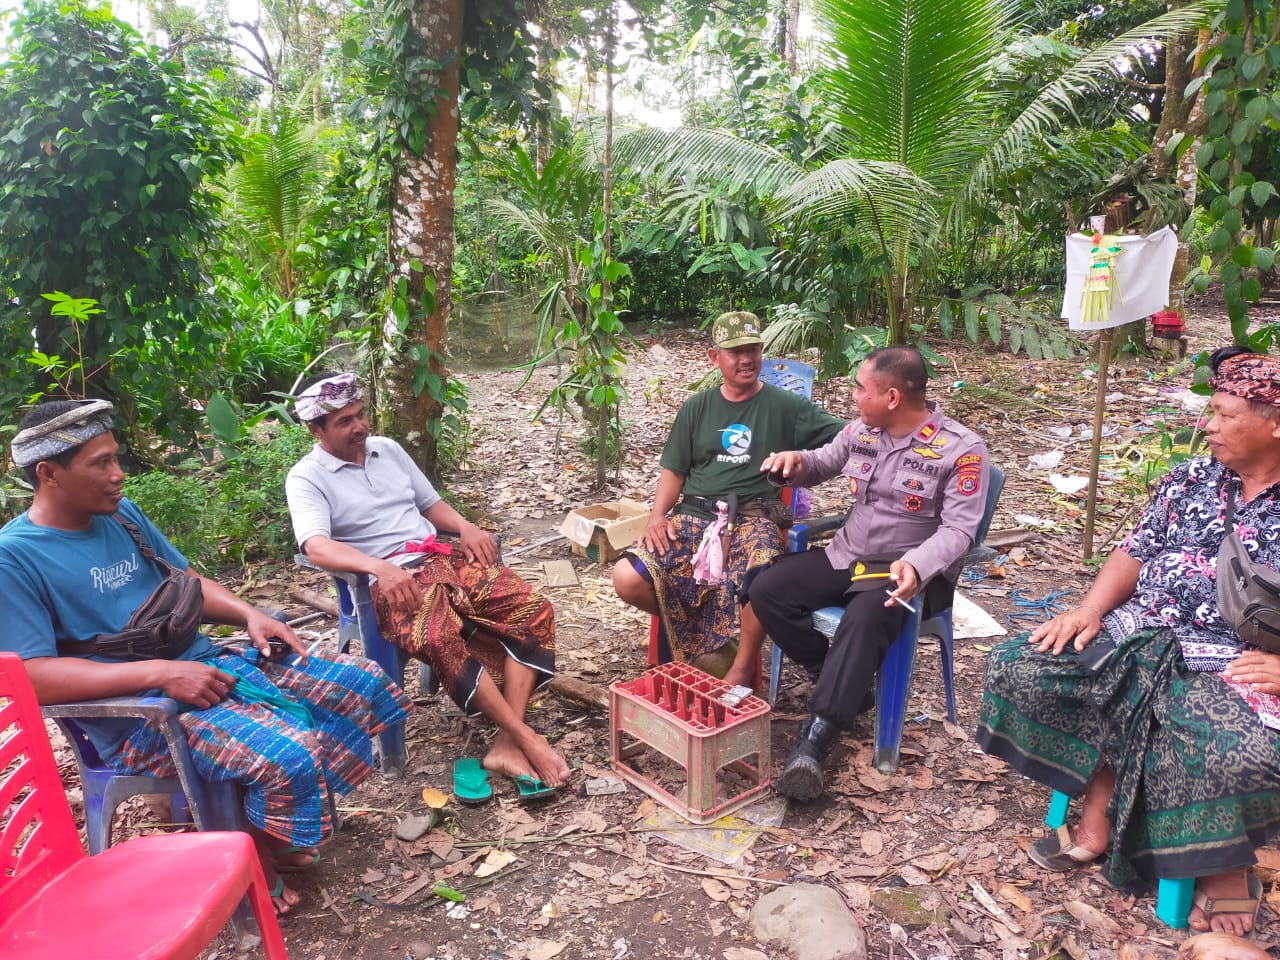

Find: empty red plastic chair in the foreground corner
[0,653,287,960]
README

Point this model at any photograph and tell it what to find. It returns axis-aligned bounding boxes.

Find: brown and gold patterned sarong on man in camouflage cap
[623,513,786,660]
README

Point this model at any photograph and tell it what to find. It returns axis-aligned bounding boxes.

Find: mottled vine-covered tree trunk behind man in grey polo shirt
[378,0,463,476]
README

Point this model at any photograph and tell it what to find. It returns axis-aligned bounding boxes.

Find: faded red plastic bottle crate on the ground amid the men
[609,663,769,823]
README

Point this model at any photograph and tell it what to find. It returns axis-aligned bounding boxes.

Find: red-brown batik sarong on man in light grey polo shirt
[372,550,556,716]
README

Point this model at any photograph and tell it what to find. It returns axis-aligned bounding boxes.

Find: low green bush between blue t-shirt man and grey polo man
[124,420,312,571]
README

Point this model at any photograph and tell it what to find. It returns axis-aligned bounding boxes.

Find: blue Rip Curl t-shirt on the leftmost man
[0,499,214,756]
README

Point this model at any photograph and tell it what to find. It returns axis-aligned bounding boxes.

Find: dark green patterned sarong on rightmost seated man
[977,630,1280,886]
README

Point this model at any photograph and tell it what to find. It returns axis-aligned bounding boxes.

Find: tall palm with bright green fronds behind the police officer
[620,0,1221,343]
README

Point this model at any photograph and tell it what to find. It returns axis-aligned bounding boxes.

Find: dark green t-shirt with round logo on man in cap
[659,384,845,515]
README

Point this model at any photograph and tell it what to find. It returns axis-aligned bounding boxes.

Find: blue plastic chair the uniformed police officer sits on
[769,466,1005,776]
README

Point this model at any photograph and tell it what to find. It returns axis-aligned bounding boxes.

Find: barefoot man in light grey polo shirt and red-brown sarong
[284,374,568,791]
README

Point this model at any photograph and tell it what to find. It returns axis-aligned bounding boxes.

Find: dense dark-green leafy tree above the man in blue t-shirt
[0,3,240,456]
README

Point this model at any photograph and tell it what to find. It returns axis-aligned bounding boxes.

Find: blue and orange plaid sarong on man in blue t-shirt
[109,650,413,847]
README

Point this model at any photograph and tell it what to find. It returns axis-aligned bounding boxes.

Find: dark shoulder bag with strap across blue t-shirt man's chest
[58,513,205,660]
